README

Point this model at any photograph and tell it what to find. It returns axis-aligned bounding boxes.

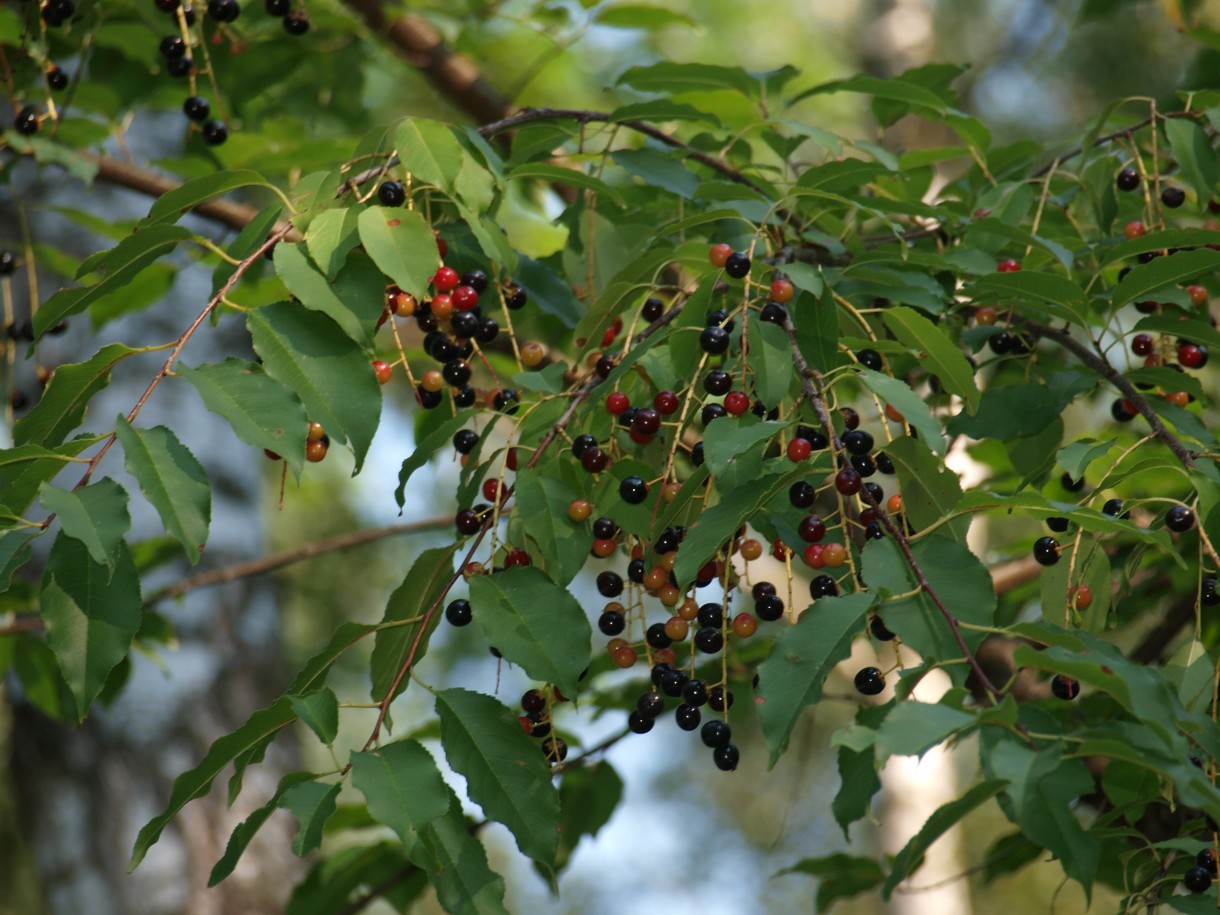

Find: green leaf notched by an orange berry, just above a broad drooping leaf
[514,467,589,587]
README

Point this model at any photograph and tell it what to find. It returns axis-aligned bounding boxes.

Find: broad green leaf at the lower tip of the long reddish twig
[351,741,453,871]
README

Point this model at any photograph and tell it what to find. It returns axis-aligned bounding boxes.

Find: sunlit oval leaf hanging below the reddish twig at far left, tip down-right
[115,416,212,565]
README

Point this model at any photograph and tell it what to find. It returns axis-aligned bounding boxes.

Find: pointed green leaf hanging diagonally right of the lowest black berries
[756,595,875,767]
